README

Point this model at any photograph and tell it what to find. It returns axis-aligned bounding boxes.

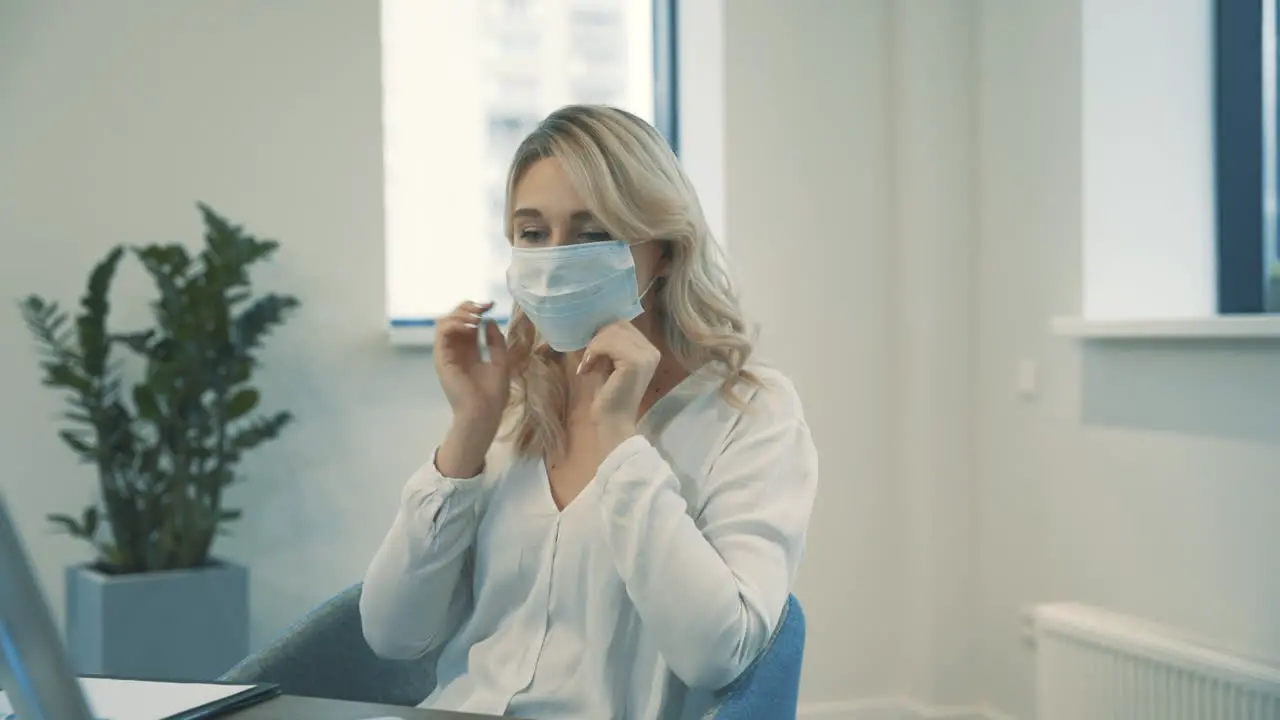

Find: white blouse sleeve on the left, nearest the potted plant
[360,450,486,660]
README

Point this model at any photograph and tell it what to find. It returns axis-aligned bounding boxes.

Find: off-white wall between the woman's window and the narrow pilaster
[724,0,902,702]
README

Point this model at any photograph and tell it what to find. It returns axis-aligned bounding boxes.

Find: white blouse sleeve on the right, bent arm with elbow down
[596,371,818,691]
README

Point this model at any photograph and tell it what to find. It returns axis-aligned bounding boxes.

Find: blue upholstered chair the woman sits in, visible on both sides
[220,584,805,720]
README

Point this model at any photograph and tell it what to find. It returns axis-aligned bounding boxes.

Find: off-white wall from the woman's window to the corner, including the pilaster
[726,0,978,716]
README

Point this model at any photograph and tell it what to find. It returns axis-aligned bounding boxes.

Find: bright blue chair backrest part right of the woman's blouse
[707,596,805,720]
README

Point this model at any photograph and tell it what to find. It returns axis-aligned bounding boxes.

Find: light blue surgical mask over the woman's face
[507,241,653,352]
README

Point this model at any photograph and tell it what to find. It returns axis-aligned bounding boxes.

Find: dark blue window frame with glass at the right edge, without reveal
[1213,0,1280,314]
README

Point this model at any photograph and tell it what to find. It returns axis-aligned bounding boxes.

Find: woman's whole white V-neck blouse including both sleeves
[360,368,818,720]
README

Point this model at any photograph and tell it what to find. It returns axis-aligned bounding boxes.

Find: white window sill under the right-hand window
[1052,315,1280,340]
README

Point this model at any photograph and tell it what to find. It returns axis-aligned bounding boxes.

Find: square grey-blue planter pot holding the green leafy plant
[67,561,248,680]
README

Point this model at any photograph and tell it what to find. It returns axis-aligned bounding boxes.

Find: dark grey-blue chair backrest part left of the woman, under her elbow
[221,584,435,707]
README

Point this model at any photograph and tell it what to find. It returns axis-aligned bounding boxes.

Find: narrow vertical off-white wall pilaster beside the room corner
[888,0,978,708]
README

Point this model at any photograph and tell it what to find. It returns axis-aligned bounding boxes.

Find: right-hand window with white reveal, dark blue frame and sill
[1055,0,1280,337]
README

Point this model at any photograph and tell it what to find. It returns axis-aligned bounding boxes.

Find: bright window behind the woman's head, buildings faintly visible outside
[381,0,678,332]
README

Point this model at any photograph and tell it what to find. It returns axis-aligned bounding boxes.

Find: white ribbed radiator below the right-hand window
[1033,603,1280,720]
